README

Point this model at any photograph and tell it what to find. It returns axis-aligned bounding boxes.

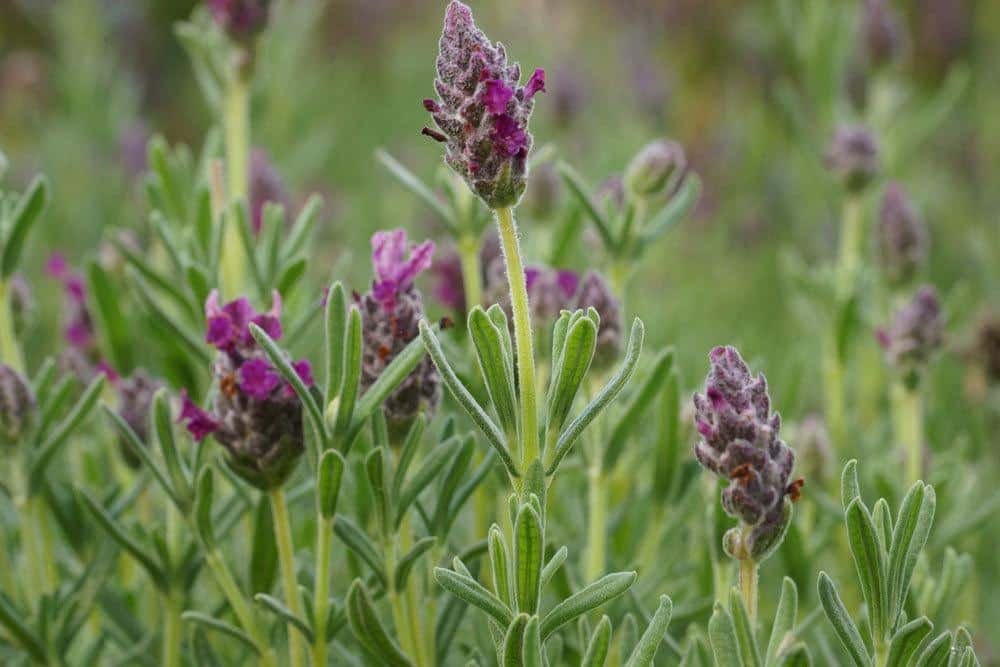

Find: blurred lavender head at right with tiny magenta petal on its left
[876,285,944,382]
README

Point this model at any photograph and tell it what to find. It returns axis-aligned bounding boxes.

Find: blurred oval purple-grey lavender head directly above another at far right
[878,183,927,284]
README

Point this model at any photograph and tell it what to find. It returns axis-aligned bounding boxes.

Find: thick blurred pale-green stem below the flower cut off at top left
[221,68,250,295]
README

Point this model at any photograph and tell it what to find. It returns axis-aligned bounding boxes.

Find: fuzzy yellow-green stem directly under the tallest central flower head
[496,208,539,470]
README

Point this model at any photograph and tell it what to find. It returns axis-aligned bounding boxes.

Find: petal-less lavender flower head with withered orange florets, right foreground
[694,347,802,561]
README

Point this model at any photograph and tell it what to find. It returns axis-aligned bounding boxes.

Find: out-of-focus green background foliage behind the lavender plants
[0,0,1000,656]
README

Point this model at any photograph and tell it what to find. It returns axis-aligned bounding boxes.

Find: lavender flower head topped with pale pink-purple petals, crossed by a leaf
[356,229,441,424]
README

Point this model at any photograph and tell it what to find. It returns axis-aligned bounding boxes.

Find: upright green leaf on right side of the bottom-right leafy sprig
[888,482,937,620]
